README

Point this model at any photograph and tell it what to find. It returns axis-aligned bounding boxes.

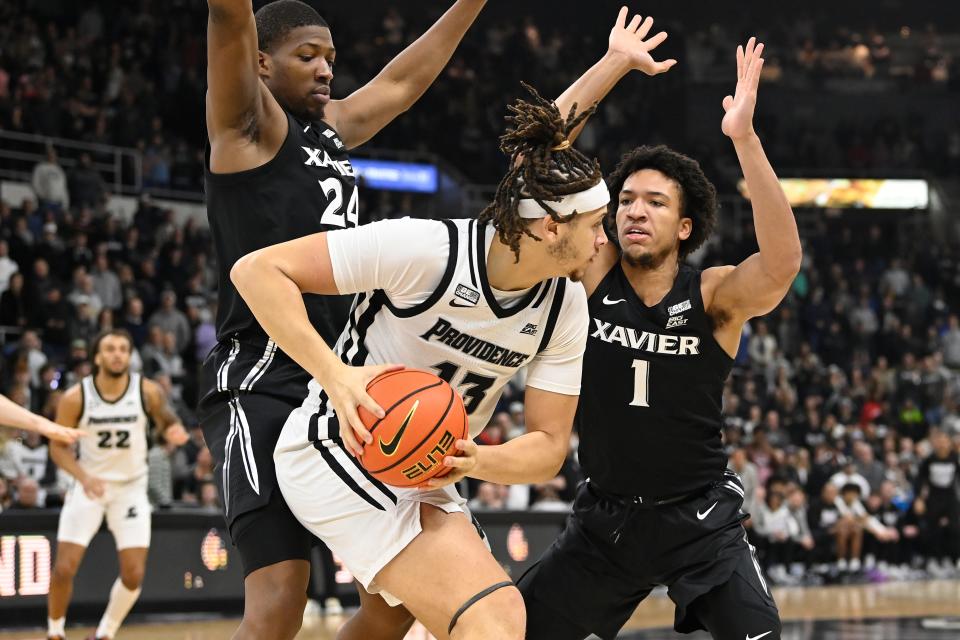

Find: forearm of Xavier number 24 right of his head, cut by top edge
[379,0,486,111]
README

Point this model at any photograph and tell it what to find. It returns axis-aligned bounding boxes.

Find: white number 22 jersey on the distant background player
[77,373,149,482]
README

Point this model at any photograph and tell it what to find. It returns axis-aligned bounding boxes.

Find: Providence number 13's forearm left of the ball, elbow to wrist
[230,252,341,385]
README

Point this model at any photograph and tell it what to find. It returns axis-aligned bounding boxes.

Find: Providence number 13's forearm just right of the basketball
[469,431,568,484]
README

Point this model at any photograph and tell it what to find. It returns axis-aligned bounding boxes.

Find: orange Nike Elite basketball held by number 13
[358,369,468,487]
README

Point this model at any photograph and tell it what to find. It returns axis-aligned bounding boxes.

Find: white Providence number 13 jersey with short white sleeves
[292,219,588,441]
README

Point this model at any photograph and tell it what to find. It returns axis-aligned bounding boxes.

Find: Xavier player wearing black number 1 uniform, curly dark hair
[519,38,801,640]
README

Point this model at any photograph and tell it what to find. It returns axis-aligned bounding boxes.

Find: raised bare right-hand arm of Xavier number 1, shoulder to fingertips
[704,38,802,342]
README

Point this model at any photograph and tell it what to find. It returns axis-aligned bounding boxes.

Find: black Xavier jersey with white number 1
[577,263,733,499]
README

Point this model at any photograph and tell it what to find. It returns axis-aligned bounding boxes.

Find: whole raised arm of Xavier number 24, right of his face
[326,0,486,149]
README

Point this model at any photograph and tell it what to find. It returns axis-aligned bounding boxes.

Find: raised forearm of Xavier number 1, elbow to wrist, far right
[733,134,803,284]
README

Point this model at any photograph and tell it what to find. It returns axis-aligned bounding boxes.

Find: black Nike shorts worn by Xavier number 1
[518,472,780,640]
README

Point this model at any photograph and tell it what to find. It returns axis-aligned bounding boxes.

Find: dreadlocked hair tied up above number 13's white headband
[479,82,603,262]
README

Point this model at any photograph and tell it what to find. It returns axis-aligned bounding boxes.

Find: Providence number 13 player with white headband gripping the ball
[231,87,609,639]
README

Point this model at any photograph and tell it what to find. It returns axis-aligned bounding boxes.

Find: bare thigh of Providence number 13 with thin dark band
[374,503,523,638]
